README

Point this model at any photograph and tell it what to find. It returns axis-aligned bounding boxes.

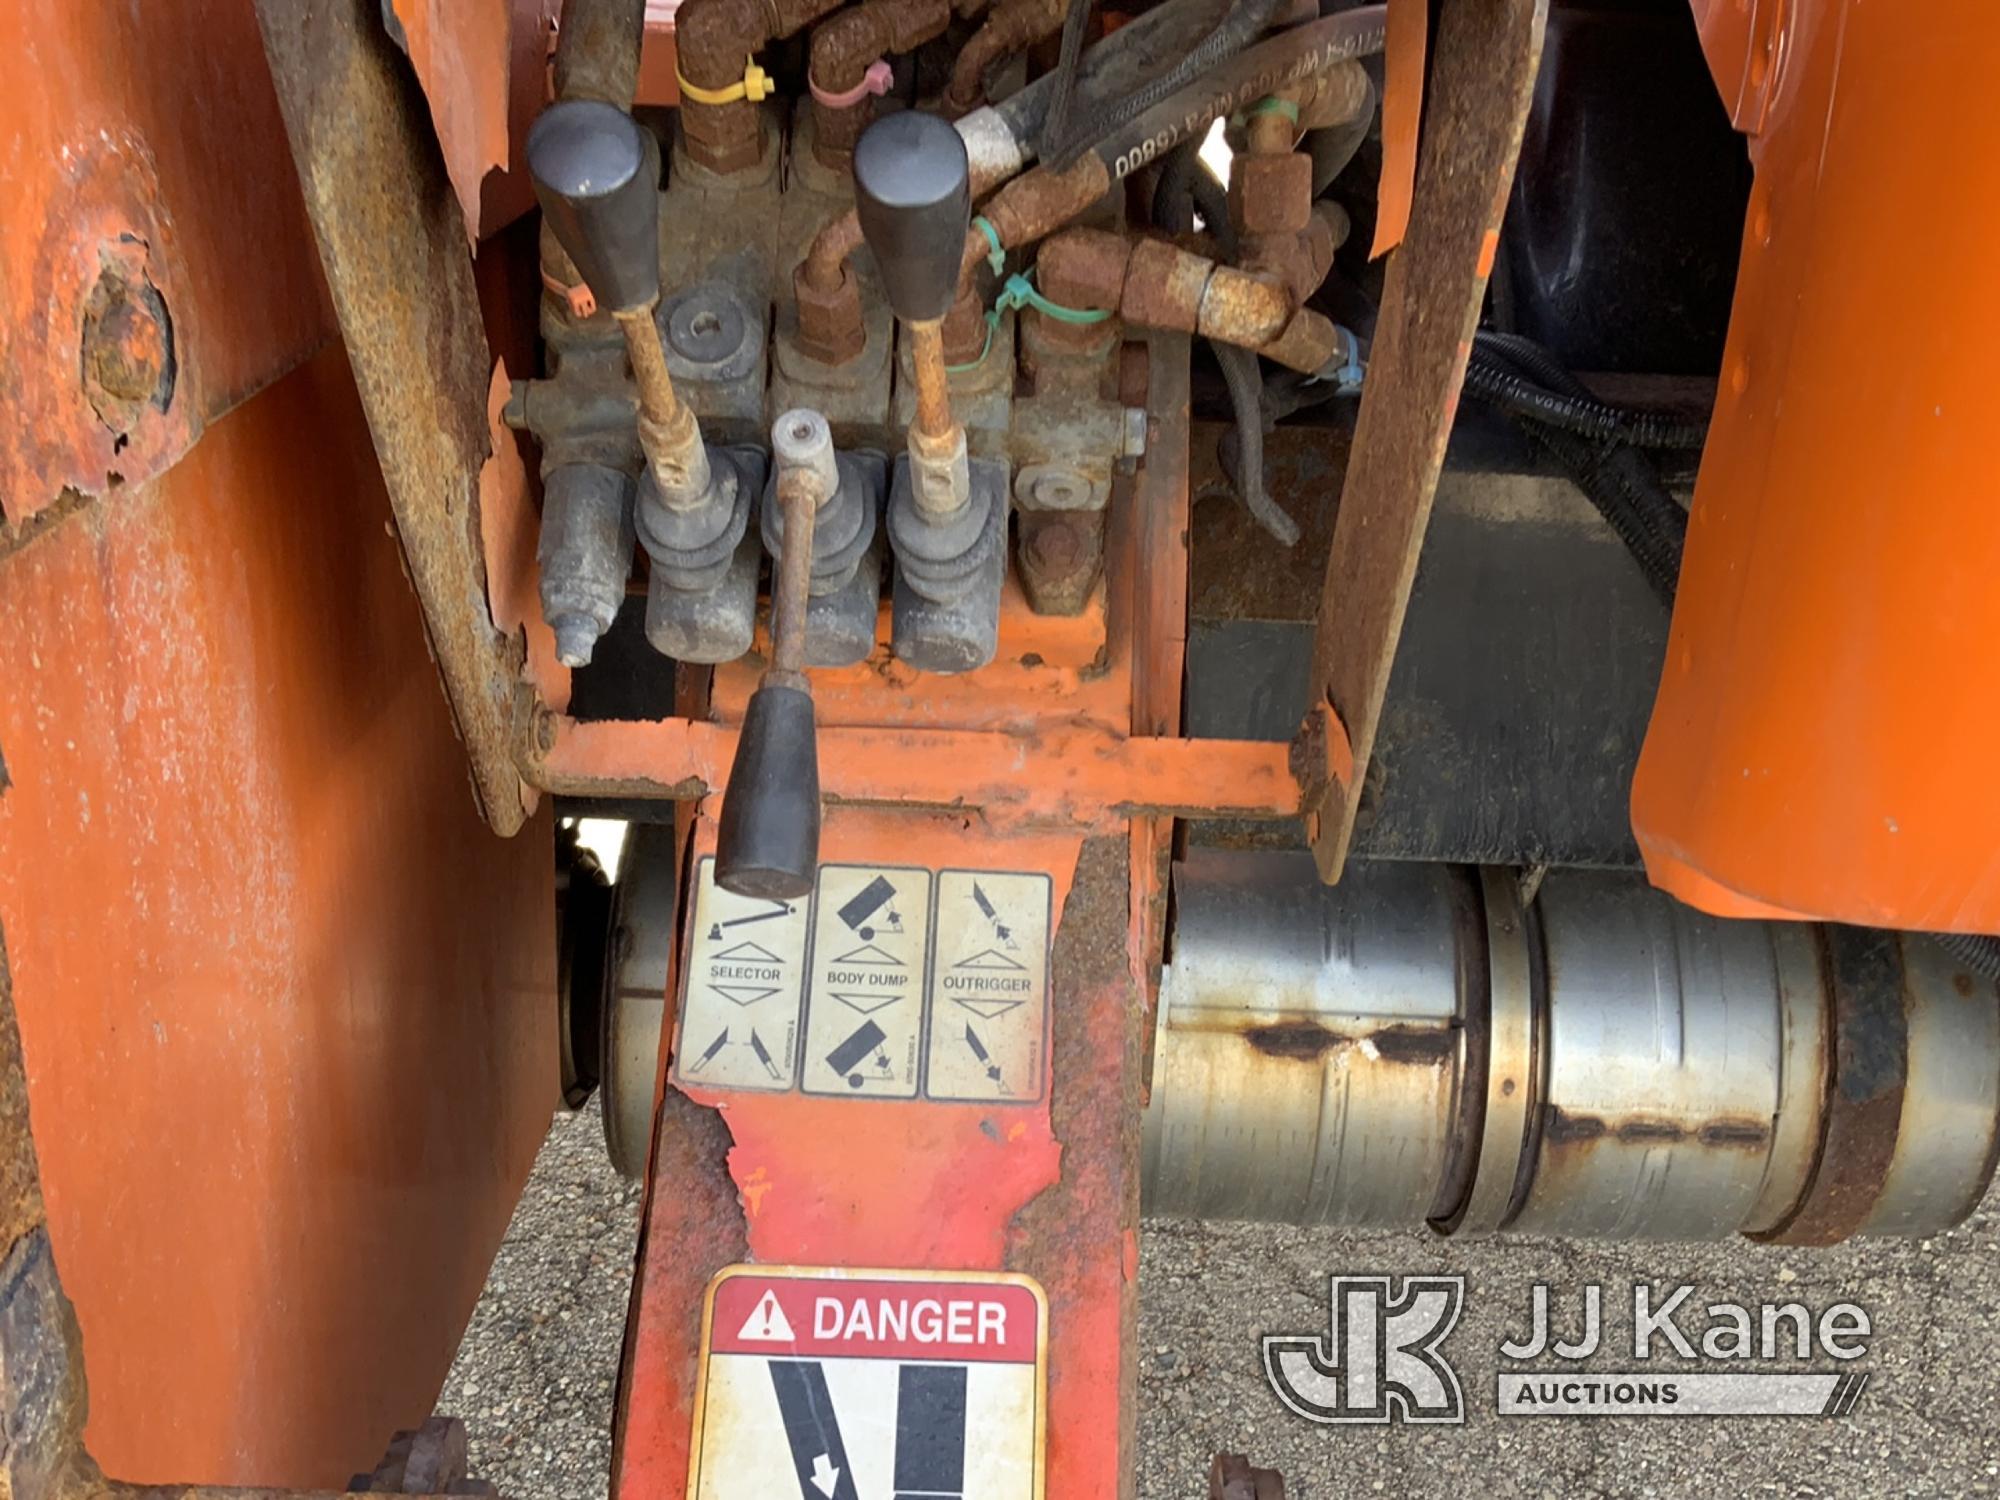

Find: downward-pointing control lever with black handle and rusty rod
[716,410,840,900]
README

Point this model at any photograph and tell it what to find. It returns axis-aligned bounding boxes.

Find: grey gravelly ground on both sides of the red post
[438,1106,2000,1500]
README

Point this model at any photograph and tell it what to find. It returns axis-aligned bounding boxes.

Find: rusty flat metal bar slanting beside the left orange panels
[258,0,532,834]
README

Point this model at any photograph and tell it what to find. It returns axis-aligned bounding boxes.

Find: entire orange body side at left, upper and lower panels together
[0,0,556,1486]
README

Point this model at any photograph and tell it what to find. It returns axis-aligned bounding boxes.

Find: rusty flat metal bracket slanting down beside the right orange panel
[1306,0,1548,882]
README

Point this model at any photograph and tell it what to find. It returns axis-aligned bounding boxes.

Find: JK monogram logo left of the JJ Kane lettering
[1264,1276,1466,1422]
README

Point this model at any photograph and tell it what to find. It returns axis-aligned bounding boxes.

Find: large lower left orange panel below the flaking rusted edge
[0,350,556,1484]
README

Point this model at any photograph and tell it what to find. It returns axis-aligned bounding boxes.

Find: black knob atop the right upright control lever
[854,110,972,322]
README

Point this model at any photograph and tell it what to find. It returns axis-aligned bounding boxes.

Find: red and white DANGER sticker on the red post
[688,1266,1048,1500]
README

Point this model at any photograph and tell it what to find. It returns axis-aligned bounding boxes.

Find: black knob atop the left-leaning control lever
[528,100,660,312]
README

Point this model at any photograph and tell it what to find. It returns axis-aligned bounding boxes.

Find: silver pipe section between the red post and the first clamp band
[1146,852,1484,1226]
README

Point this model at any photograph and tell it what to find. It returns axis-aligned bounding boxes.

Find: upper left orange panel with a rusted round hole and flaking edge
[0,0,332,528]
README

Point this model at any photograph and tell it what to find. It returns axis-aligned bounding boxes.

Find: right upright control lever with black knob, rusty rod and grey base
[854,110,1008,672]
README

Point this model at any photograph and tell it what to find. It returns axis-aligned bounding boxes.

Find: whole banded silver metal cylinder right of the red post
[1144,850,2000,1244]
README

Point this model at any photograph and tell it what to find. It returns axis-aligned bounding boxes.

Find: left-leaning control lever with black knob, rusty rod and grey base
[528,100,764,662]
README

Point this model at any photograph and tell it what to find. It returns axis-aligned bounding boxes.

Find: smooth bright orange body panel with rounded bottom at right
[1632,0,2000,932]
